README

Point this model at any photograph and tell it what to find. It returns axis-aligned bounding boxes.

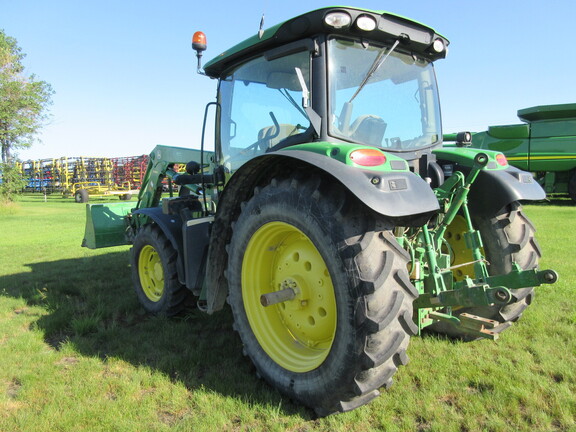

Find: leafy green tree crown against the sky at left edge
[0,30,54,163]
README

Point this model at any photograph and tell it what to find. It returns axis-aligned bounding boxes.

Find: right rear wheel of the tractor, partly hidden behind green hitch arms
[431,202,541,340]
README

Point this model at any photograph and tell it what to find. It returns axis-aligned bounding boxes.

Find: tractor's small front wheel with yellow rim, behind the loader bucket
[131,224,191,316]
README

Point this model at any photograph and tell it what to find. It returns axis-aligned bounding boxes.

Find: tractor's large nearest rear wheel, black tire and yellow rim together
[226,178,418,416]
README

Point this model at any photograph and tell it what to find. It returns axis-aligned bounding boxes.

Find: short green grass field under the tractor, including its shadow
[0,195,576,432]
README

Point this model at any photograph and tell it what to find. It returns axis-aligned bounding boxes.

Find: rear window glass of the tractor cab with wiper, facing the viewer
[328,39,442,152]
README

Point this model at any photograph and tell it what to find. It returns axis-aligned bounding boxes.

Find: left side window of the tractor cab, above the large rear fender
[220,51,310,171]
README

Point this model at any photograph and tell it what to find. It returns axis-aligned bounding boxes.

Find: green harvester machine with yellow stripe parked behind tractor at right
[450,104,576,202]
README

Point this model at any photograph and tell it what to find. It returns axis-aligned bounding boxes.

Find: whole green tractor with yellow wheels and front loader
[84,7,557,415]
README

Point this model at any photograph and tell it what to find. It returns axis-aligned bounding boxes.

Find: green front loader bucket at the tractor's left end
[82,202,135,249]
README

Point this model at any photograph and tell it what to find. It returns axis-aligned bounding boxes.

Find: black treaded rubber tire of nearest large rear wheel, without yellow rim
[227,175,418,416]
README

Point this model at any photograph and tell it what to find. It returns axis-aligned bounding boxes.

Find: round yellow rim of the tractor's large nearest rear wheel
[242,222,337,372]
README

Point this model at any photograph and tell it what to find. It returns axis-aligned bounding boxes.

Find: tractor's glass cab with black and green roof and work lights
[195,8,448,177]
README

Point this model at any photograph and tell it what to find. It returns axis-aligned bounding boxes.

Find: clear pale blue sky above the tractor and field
[0,0,576,160]
